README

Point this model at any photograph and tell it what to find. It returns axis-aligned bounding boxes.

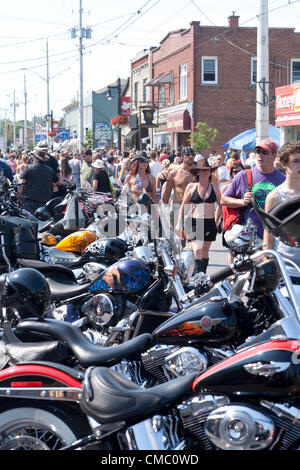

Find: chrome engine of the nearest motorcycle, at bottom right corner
[178,395,300,450]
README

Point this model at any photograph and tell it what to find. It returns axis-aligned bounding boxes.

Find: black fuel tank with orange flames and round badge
[153,298,243,346]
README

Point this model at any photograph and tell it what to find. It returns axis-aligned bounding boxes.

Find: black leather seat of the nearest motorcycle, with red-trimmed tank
[80,367,197,423]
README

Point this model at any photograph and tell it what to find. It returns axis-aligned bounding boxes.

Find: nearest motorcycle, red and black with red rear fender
[0,250,300,451]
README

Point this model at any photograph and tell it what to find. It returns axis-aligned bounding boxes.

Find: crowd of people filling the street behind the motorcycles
[0,139,300,272]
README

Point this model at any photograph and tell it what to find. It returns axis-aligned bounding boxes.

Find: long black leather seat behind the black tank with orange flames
[15,319,152,368]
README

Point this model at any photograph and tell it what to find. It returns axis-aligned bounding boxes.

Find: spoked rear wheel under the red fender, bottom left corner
[0,407,81,450]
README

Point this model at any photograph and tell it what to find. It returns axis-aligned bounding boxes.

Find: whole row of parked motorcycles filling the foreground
[0,173,300,451]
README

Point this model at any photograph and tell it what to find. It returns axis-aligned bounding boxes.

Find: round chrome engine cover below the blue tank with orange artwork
[81,294,118,326]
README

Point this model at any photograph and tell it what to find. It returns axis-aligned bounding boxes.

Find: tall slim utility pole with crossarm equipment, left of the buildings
[70,0,92,151]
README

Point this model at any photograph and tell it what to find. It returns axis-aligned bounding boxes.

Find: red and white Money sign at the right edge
[275,84,300,127]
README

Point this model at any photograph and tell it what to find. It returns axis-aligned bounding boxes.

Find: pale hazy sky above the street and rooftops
[0,0,300,125]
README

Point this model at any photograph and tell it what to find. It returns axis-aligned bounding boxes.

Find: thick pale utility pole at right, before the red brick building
[256,0,270,141]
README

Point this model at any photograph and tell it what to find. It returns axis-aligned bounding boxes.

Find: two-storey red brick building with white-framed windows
[131,14,300,152]
